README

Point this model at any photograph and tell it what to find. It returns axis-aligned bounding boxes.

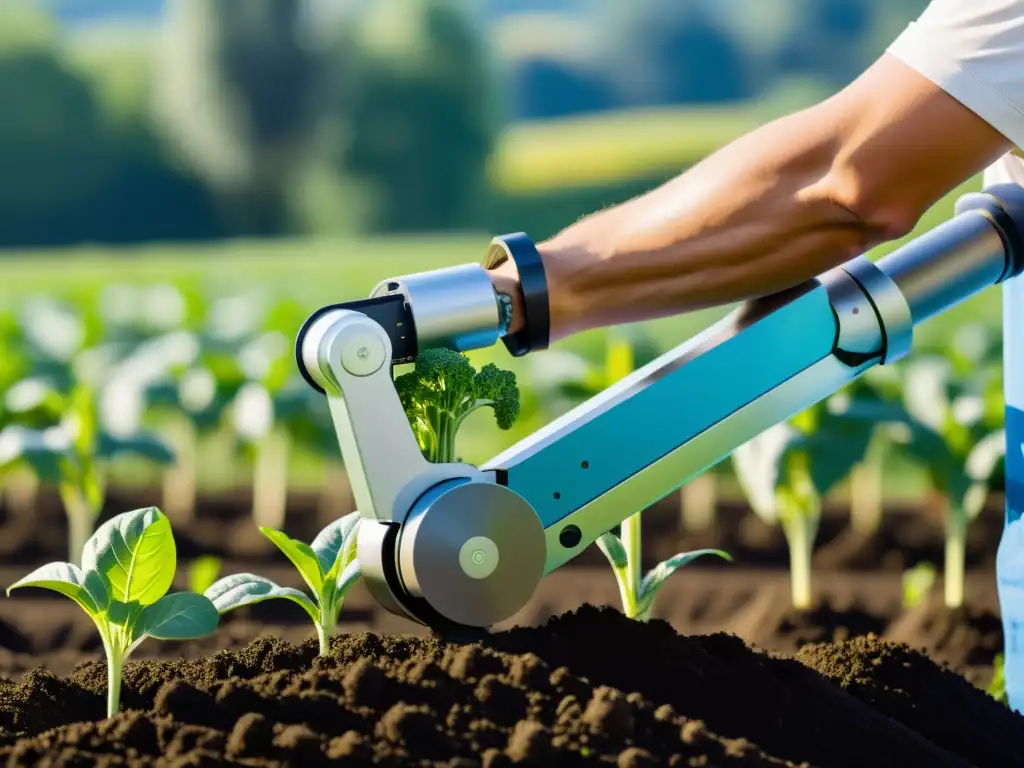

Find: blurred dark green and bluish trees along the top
[0,0,926,247]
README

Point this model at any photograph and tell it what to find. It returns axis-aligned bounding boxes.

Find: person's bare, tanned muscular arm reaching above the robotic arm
[494,9,1024,340]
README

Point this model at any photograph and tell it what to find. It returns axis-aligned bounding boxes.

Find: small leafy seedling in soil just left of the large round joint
[204,512,359,655]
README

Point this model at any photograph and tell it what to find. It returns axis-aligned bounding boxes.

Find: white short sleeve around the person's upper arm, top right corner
[888,0,1024,147]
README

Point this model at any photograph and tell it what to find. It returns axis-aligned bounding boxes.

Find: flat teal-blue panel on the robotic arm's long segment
[481,285,838,528]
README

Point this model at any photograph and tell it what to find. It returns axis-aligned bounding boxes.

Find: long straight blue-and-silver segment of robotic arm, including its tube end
[481,186,1024,572]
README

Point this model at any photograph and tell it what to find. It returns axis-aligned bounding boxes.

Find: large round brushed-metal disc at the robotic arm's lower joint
[398,479,546,627]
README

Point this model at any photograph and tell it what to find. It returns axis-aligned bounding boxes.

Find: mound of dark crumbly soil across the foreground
[0,607,1024,768]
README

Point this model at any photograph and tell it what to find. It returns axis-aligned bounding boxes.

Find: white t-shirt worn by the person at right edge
[889,0,1024,405]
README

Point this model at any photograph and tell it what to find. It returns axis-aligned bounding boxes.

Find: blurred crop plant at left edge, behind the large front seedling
[0,379,174,560]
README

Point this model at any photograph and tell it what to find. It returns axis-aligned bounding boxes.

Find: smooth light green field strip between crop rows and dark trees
[0,171,1001,348]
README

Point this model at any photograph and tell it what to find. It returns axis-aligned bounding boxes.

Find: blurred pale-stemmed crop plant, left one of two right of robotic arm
[732,399,874,610]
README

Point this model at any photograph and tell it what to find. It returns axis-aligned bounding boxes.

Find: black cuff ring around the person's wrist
[483,232,551,357]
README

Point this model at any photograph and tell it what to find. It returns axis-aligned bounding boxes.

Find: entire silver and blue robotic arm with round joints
[296,184,1024,631]
